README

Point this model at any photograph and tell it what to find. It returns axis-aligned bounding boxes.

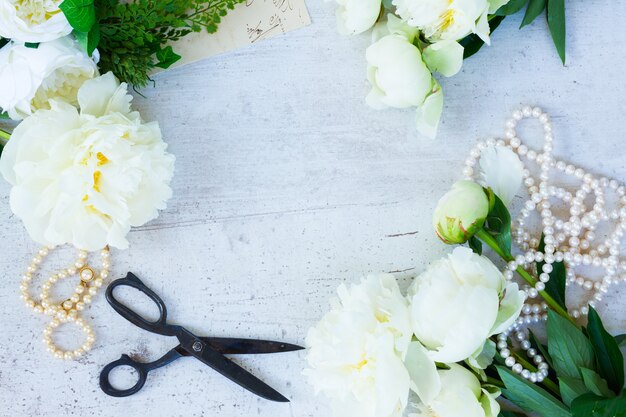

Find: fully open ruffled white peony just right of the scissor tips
[304,274,412,417]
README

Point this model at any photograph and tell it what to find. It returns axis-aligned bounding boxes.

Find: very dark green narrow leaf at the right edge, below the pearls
[587,307,624,394]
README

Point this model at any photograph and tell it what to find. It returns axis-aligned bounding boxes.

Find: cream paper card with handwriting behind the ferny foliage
[163,0,311,68]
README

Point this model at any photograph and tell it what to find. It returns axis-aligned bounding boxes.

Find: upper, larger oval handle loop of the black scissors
[106,272,179,336]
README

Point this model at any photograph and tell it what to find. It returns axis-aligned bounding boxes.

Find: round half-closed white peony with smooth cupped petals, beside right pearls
[409,247,525,363]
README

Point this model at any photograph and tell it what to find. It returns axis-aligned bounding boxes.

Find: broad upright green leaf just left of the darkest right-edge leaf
[548,310,594,378]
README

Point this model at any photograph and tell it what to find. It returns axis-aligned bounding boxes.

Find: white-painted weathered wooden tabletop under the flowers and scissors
[0,0,626,417]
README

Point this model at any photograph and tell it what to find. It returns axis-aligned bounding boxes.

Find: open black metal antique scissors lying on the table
[100,272,303,402]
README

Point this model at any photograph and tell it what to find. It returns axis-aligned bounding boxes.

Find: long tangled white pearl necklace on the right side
[463,106,626,382]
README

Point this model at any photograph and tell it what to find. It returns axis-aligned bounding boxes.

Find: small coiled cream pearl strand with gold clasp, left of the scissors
[20,247,110,360]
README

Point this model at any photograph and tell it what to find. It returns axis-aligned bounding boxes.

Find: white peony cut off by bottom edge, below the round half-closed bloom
[410,364,500,417]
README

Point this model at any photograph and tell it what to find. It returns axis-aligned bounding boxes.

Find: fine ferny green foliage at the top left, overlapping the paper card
[91,0,244,87]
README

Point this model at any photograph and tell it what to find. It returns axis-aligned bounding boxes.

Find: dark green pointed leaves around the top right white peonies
[459,0,566,64]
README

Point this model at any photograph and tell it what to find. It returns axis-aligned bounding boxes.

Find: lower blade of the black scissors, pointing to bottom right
[192,346,289,403]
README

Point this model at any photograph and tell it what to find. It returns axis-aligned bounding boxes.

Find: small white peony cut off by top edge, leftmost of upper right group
[336,0,381,35]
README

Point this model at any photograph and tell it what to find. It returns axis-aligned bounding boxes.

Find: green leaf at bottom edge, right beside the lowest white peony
[496,366,571,417]
